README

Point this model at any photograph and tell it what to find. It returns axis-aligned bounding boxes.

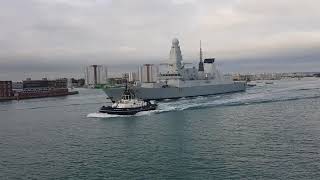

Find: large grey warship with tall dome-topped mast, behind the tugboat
[103,38,246,102]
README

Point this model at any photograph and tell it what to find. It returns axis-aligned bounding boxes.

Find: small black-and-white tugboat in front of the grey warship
[99,84,158,115]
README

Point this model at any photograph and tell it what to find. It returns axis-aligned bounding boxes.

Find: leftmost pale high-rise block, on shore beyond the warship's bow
[85,65,108,85]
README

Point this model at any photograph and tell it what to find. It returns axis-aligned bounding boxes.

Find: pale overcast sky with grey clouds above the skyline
[0,0,320,78]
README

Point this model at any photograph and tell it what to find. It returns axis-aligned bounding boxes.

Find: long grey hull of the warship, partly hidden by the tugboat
[103,82,246,102]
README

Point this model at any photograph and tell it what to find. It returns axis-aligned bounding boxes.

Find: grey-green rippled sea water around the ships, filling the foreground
[0,78,320,180]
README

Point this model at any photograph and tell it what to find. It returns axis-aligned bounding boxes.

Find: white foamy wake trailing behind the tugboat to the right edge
[87,80,320,118]
